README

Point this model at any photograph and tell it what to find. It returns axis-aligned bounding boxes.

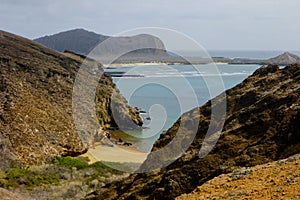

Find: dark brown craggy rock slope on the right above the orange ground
[91,65,300,199]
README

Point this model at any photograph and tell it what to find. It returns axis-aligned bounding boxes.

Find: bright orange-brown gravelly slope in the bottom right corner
[176,154,300,200]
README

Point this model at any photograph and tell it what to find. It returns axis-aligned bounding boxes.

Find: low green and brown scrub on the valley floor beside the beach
[0,157,127,190]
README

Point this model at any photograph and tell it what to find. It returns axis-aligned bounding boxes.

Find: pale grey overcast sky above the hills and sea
[0,0,300,50]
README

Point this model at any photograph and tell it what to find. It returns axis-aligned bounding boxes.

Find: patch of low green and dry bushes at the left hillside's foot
[0,156,127,197]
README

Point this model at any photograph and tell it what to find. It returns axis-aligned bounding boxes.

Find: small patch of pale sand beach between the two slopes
[81,145,148,163]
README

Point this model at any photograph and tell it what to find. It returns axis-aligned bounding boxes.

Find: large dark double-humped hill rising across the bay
[34,29,168,59]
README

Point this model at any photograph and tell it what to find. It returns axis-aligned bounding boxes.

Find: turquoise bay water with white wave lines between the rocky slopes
[105,64,260,151]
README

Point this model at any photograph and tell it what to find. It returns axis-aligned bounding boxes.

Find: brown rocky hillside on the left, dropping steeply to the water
[0,31,142,168]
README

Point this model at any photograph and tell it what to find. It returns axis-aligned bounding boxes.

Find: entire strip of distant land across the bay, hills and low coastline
[34,29,300,65]
